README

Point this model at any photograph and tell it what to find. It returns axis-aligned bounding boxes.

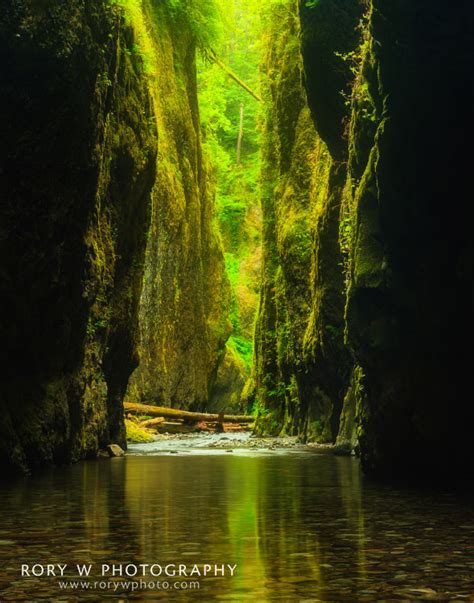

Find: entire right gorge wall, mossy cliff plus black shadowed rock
[254,0,474,484]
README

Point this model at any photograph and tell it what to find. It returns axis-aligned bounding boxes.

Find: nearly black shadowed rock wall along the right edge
[301,0,474,479]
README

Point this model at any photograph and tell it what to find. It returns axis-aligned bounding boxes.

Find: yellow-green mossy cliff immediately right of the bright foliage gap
[250,0,357,441]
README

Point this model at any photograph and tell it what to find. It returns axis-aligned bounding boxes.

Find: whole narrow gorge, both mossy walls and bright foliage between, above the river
[0,0,474,484]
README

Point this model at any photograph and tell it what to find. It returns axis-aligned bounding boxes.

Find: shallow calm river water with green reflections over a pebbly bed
[0,440,474,603]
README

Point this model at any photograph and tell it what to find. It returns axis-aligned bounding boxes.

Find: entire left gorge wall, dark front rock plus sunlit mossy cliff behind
[0,0,230,471]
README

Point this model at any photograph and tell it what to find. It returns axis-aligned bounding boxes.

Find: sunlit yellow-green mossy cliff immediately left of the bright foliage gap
[125,2,231,409]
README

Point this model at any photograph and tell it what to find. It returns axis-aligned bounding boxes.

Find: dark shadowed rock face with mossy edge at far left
[0,0,156,470]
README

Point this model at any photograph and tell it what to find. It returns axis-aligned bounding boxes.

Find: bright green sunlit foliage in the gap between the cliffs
[196,0,262,382]
